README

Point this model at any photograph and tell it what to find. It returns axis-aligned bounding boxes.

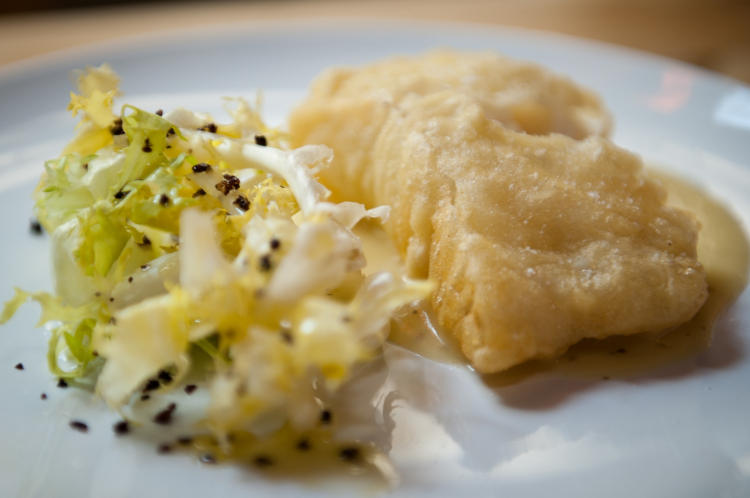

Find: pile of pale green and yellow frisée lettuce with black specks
[0,65,431,452]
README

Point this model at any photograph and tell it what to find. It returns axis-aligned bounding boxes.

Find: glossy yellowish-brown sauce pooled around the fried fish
[357,169,750,386]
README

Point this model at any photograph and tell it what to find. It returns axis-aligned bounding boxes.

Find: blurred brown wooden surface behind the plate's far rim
[0,0,750,83]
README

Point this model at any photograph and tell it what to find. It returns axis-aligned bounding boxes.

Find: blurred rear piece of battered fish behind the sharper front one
[290,50,612,208]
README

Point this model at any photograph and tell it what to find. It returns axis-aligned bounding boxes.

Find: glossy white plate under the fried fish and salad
[0,20,750,498]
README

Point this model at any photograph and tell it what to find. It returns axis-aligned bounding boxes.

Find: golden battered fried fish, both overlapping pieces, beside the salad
[290,52,707,372]
